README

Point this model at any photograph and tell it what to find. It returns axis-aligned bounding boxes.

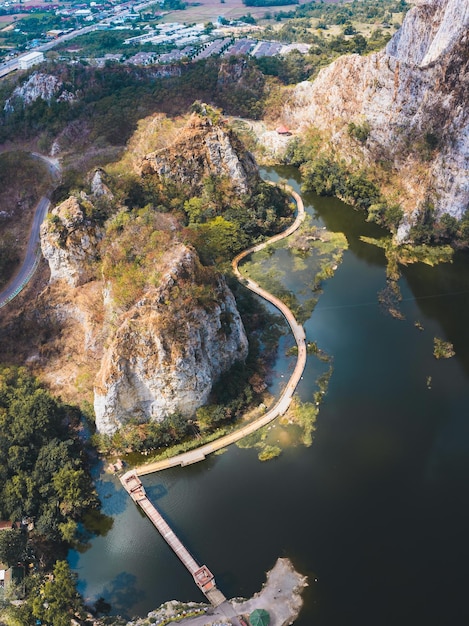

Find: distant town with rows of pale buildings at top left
[0,0,309,76]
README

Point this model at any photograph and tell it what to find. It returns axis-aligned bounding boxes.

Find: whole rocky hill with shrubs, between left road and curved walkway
[2,108,290,445]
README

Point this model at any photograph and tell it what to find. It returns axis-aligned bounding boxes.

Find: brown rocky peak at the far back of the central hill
[141,114,258,193]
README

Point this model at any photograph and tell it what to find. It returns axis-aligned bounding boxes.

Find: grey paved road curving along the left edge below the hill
[0,152,60,308]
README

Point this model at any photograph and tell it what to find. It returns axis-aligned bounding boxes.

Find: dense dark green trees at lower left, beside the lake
[0,367,98,542]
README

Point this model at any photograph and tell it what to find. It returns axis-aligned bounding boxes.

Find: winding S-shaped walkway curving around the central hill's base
[134,183,306,476]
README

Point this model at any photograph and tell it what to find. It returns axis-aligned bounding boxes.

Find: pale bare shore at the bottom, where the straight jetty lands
[127,559,308,626]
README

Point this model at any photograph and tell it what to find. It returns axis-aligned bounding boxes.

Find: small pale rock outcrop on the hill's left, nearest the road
[41,196,103,287]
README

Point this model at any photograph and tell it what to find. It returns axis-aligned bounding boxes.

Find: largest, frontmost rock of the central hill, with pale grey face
[94,244,247,434]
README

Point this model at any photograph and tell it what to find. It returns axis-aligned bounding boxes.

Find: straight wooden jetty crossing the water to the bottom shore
[120,471,226,606]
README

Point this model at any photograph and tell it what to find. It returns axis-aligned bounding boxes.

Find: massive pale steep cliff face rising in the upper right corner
[284,0,469,225]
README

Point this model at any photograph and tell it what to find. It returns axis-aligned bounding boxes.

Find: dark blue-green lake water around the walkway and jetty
[69,168,469,626]
